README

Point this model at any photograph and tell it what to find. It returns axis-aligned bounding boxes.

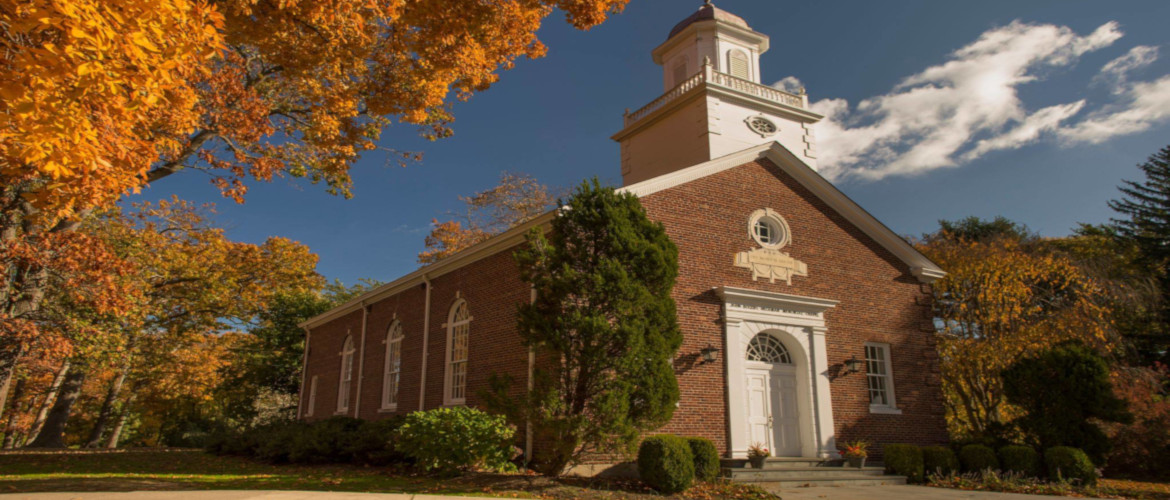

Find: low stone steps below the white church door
[722,457,906,488]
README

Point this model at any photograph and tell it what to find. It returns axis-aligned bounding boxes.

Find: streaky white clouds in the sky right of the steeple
[809,21,1170,179]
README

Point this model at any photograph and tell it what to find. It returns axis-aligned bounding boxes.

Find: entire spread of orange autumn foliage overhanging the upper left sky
[0,0,626,219]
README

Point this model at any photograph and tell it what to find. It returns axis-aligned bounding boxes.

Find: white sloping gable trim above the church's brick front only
[619,142,947,283]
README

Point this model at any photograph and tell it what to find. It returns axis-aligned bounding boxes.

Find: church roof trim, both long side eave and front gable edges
[301,142,947,328]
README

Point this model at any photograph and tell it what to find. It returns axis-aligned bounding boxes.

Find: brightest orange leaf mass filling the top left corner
[0,0,222,218]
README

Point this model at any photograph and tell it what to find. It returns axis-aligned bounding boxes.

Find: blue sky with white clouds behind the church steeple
[135,0,1170,283]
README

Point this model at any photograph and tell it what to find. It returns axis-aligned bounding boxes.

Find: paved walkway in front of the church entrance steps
[772,486,1060,500]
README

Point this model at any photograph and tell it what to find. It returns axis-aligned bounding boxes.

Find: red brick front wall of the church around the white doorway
[641,160,947,451]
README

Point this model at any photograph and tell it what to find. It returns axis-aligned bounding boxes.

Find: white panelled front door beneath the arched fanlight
[744,363,800,457]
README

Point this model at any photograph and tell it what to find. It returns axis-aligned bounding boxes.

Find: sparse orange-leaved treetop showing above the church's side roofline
[419,172,557,265]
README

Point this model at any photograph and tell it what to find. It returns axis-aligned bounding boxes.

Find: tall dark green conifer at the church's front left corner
[494,178,682,474]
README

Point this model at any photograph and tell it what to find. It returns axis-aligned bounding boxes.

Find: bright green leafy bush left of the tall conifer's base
[397,406,516,473]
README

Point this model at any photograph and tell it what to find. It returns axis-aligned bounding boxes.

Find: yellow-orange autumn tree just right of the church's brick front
[917,218,1117,439]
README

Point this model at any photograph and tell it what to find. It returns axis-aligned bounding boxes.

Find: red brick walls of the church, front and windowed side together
[302,160,945,459]
